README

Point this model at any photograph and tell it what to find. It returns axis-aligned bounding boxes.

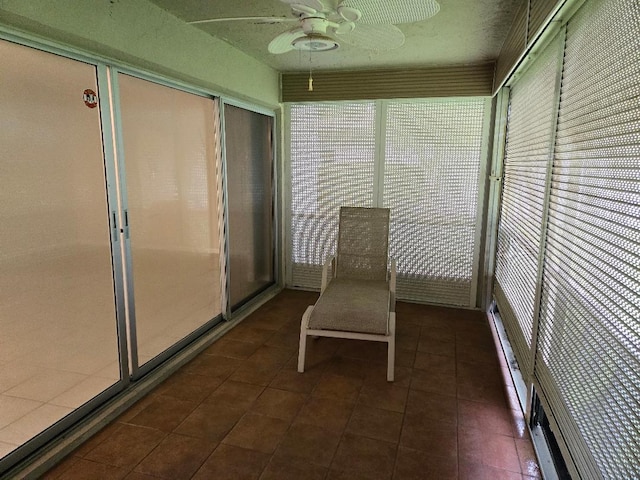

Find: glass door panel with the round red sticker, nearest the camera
[0,41,120,458]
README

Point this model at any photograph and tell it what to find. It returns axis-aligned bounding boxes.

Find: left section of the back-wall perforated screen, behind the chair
[289,102,376,288]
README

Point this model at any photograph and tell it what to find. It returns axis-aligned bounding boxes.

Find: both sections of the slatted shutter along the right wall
[495,0,640,479]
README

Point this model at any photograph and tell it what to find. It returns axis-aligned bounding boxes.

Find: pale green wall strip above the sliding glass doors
[0,0,279,107]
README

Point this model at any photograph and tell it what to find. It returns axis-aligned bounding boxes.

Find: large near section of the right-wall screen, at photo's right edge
[535,0,640,479]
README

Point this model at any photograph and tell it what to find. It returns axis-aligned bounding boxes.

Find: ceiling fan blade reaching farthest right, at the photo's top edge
[340,0,440,25]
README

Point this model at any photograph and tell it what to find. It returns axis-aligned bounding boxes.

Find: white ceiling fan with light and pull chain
[188,0,440,54]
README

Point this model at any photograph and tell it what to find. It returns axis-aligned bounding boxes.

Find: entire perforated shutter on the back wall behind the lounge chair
[288,98,490,306]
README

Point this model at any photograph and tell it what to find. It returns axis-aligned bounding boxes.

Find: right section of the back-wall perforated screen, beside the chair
[383,99,485,306]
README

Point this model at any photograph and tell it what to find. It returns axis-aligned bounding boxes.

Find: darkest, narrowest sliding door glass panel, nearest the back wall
[224,105,274,307]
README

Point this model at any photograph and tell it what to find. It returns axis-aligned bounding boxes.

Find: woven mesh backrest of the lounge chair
[336,207,390,280]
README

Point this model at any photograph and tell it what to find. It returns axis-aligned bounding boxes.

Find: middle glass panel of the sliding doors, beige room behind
[119,75,220,364]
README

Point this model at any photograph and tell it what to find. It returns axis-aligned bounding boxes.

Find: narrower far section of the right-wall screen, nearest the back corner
[494,36,564,374]
